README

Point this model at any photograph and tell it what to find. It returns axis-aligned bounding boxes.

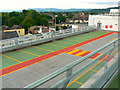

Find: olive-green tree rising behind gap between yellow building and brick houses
[20,16,35,33]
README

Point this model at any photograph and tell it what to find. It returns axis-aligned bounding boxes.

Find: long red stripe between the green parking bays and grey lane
[0,32,114,76]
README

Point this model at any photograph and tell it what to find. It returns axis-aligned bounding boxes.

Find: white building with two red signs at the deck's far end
[89,9,120,31]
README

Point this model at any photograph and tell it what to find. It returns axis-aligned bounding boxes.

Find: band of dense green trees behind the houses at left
[2,10,66,31]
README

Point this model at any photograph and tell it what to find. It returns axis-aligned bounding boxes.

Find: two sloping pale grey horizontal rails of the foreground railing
[23,38,120,90]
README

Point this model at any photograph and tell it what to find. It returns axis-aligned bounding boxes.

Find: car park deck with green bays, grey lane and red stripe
[1,31,118,88]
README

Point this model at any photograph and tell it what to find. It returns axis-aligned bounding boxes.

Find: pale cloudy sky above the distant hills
[0,0,119,10]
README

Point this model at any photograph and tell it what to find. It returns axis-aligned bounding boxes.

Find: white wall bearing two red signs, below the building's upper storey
[89,15,120,31]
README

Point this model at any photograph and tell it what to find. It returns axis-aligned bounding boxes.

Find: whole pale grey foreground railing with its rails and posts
[23,38,120,90]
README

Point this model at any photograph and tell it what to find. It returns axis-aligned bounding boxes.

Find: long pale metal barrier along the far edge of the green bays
[0,26,96,52]
